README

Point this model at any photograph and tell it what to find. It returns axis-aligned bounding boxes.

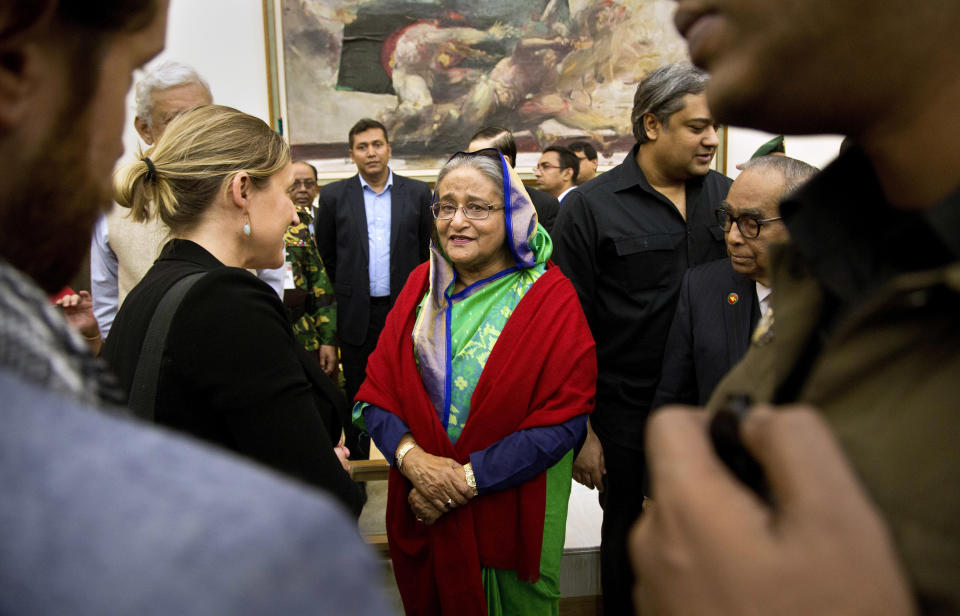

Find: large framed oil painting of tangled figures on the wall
[276,0,687,174]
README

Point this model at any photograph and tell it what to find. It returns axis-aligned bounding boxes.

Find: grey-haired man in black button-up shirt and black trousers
[553,64,731,616]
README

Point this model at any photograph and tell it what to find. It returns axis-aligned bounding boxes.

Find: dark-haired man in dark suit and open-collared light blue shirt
[315,118,433,459]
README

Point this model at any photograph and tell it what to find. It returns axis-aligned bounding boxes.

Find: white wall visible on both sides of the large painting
[124,0,841,177]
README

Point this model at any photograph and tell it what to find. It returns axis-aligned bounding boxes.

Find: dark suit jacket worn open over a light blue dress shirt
[314,173,433,345]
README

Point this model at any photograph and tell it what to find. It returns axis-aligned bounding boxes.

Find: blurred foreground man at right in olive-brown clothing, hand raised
[632,0,960,614]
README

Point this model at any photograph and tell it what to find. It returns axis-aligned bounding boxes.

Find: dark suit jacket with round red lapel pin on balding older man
[652,258,760,408]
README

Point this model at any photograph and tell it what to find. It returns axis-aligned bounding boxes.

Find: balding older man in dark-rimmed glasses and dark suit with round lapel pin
[651,156,817,408]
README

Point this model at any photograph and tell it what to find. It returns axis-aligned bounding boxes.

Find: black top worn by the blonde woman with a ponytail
[103,240,362,515]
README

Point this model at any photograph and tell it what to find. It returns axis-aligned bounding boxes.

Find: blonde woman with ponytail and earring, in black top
[103,105,362,515]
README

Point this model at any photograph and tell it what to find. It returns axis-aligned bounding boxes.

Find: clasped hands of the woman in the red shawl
[400,447,475,526]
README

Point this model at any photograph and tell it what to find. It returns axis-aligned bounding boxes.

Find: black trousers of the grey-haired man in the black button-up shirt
[600,438,648,616]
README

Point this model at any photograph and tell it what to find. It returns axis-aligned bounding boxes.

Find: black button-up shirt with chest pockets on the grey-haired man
[553,145,732,450]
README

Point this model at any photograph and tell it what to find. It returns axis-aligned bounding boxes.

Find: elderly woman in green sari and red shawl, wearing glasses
[354,150,596,615]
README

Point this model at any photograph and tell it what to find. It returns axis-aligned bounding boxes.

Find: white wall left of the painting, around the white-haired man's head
[123,0,270,164]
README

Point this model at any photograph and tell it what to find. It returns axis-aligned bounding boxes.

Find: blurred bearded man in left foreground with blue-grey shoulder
[0,0,386,615]
